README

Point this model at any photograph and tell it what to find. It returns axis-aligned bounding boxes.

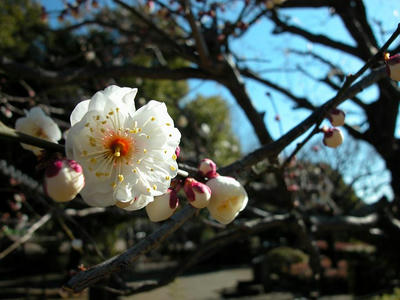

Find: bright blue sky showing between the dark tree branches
[40,0,400,202]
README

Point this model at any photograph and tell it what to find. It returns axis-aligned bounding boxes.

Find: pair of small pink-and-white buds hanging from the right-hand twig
[321,108,346,148]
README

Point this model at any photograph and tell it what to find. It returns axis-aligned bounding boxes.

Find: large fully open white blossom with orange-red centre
[66,86,181,210]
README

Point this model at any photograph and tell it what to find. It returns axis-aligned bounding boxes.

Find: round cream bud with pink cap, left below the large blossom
[44,159,85,202]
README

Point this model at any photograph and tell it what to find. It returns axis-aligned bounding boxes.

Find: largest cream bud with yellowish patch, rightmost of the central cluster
[207,176,248,224]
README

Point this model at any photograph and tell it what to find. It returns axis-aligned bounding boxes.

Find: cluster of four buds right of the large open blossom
[146,158,248,224]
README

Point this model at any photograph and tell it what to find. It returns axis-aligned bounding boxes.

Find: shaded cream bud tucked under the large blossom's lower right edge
[146,189,179,222]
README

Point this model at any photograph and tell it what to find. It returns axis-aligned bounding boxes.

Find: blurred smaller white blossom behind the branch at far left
[15,107,61,155]
